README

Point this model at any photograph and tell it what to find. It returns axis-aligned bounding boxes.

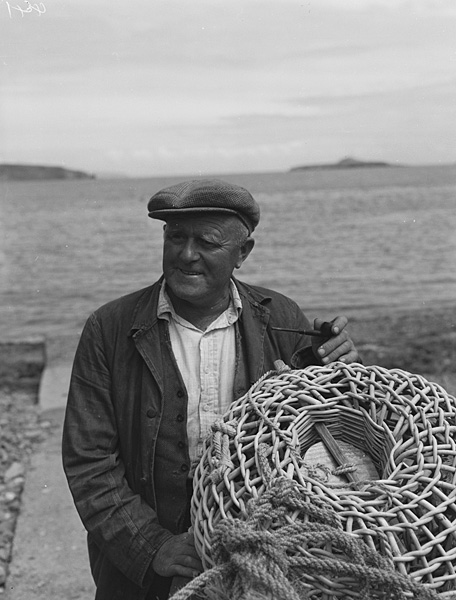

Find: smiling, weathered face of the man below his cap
[163,213,253,309]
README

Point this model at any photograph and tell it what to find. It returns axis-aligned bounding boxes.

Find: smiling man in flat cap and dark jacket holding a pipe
[63,180,358,600]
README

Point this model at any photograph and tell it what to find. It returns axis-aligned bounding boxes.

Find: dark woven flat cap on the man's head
[147,179,260,233]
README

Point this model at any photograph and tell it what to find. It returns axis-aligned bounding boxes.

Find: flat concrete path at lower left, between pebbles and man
[5,408,95,600]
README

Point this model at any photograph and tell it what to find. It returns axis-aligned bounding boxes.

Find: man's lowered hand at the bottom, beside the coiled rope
[152,532,203,579]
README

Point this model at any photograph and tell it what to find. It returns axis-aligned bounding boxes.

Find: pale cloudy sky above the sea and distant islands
[0,0,456,177]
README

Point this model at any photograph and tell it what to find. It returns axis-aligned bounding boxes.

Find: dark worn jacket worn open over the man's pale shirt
[63,281,319,600]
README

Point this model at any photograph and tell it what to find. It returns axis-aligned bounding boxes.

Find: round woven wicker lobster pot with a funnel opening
[192,363,456,598]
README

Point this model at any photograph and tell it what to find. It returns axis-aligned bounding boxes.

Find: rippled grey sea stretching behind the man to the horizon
[0,165,456,363]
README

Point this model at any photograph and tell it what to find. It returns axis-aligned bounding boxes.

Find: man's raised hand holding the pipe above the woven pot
[312,316,359,365]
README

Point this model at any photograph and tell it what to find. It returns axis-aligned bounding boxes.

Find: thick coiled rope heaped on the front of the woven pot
[172,477,439,600]
